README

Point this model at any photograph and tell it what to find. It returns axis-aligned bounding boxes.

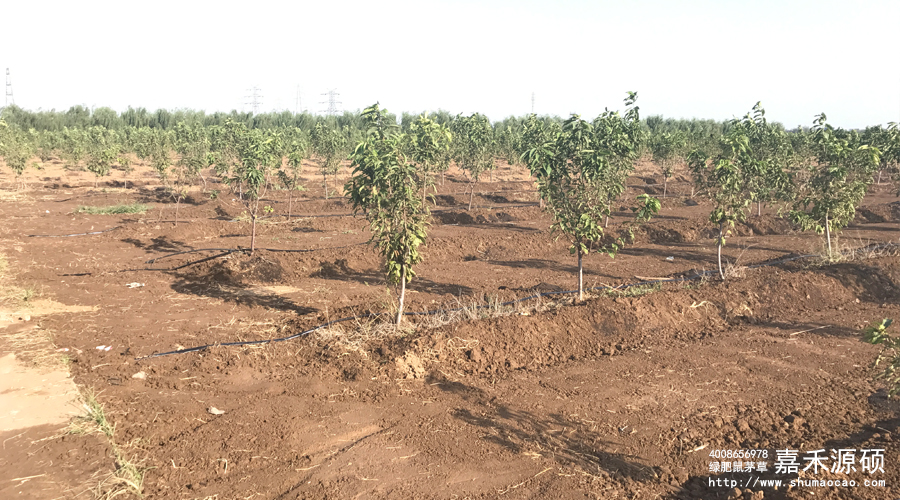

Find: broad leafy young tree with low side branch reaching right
[524,94,660,301]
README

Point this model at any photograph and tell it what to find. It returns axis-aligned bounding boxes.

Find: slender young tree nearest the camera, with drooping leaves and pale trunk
[344,103,431,325]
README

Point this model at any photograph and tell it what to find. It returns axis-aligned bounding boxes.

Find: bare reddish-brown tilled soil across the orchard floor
[0,158,900,499]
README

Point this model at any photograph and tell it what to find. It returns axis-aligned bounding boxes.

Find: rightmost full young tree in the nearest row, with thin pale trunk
[791,113,881,258]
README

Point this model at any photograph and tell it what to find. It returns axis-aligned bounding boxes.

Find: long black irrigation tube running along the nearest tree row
[135,242,900,361]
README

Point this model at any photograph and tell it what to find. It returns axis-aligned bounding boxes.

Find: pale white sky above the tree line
[0,0,900,128]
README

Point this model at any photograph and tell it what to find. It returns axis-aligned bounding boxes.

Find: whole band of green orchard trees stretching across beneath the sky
[0,97,900,321]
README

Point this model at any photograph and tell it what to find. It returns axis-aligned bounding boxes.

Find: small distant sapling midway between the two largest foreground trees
[450,113,494,210]
